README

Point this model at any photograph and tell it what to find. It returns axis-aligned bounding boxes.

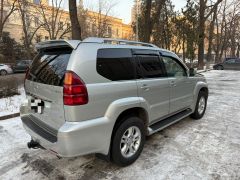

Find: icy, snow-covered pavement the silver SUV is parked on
[0,71,240,180]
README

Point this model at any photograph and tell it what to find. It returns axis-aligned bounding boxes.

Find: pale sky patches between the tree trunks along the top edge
[65,0,187,24]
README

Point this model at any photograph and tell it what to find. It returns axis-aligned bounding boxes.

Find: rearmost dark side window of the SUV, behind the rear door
[97,49,135,81]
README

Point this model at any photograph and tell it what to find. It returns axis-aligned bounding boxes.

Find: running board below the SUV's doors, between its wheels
[148,109,192,135]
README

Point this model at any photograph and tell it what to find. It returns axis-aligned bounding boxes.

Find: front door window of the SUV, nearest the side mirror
[162,57,187,77]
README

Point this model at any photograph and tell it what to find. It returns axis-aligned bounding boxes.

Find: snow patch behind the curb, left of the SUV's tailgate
[0,87,26,117]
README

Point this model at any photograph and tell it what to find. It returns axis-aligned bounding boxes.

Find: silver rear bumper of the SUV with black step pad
[20,102,114,157]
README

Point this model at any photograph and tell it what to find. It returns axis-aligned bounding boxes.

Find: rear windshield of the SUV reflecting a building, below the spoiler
[28,48,72,86]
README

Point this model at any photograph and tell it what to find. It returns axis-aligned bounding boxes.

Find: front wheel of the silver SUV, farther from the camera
[191,91,208,119]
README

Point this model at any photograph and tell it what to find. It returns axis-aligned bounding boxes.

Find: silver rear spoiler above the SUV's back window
[35,40,81,51]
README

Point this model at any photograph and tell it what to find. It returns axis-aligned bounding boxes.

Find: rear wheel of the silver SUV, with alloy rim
[111,116,145,167]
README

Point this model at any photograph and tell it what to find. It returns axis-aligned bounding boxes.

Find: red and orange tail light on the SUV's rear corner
[63,71,88,106]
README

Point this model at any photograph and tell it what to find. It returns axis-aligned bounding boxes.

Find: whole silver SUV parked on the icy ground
[20,38,208,166]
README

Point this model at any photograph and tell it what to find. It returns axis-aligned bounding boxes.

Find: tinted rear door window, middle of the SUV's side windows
[137,55,165,78]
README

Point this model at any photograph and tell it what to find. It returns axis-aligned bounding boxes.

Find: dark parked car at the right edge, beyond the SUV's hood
[213,58,240,70]
